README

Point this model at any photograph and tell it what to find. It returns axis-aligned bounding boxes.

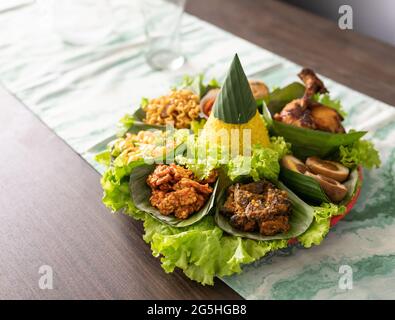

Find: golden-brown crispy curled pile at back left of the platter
[143,90,200,129]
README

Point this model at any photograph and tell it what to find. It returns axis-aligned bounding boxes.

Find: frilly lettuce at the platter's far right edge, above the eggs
[339,140,381,169]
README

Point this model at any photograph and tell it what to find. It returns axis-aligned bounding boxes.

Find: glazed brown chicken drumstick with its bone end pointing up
[274,68,345,133]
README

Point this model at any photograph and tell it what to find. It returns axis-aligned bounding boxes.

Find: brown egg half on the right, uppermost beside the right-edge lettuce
[306,157,350,182]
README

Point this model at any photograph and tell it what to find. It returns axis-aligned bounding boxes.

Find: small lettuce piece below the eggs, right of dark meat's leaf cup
[297,203,346,248]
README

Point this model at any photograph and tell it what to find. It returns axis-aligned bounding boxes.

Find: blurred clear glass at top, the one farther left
[52,0,113,45]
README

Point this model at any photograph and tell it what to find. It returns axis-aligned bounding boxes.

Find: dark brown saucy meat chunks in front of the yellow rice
[220,180,292,236]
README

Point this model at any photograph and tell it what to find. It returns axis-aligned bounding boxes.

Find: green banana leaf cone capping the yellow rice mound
[212,54,257,124]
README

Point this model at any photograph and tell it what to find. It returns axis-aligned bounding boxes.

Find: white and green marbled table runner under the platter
[0,0,395,299]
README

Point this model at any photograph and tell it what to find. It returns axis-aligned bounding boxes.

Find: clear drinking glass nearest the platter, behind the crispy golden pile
[140,0,186,70]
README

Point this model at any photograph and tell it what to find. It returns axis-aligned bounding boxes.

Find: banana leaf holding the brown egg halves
[280,168,359,205]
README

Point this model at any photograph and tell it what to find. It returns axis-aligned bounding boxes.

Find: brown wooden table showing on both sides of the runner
[0,0,395,299]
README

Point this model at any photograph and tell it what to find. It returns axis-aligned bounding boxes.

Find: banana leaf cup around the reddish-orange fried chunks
[129,165,218,228]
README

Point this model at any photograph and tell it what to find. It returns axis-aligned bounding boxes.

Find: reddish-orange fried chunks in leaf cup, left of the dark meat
[147,164,217,219]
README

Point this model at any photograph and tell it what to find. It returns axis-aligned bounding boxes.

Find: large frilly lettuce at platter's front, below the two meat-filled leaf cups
[144,216,287,285]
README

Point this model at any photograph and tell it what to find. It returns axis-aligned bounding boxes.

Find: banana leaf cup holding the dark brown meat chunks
[215,182,314,241]
